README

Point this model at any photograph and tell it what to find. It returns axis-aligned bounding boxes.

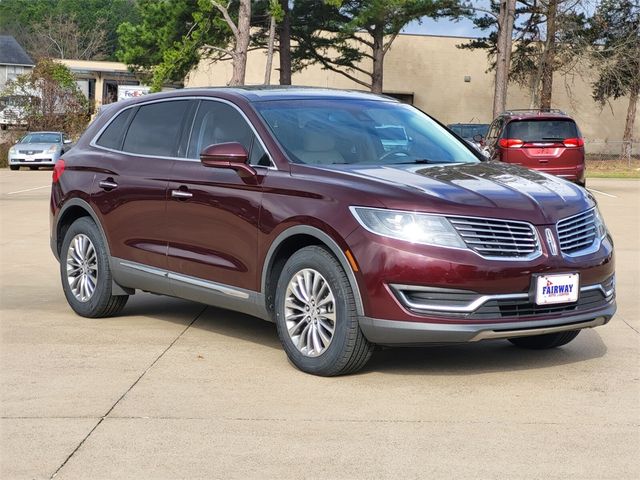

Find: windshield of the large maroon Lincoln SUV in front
[256,100,479,165]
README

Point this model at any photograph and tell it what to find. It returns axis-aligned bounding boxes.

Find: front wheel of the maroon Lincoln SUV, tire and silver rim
[276,246,373,377]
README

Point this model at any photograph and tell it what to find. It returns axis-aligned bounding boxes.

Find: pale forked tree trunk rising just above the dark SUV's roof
[208,0,251,86]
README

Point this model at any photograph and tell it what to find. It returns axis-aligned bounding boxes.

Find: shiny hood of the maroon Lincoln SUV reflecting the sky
[314,162,595,225]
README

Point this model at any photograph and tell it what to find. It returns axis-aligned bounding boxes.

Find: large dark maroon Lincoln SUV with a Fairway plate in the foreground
[51,88,616,375]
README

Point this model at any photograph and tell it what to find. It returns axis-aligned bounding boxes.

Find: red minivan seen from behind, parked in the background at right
[482,110,585,187]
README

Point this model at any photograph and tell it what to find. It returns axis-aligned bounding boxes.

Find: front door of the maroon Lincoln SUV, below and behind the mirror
[165,99,269,290]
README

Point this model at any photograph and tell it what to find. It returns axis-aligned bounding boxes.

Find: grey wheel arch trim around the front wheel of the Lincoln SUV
[260,225,364,316]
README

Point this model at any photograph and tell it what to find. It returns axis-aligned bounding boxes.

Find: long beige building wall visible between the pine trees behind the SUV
[186,35,640,151]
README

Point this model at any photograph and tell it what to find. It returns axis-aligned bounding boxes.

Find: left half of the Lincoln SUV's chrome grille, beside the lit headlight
[447,217,540,258]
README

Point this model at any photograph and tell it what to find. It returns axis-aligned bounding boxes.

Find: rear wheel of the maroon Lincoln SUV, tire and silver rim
[60,217,129,318]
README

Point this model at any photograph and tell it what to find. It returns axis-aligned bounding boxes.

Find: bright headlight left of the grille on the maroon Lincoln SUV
[351,207,466,248]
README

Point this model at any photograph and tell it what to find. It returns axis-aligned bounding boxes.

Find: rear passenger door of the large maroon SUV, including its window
[92,99,193,269]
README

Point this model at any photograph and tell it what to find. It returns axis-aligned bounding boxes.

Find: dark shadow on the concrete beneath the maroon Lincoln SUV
[123,295,607,376]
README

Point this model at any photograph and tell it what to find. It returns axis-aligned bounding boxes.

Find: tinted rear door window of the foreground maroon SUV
[123,100,189,157]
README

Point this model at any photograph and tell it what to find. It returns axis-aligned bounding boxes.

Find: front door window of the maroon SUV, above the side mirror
[187,101,252,158]
